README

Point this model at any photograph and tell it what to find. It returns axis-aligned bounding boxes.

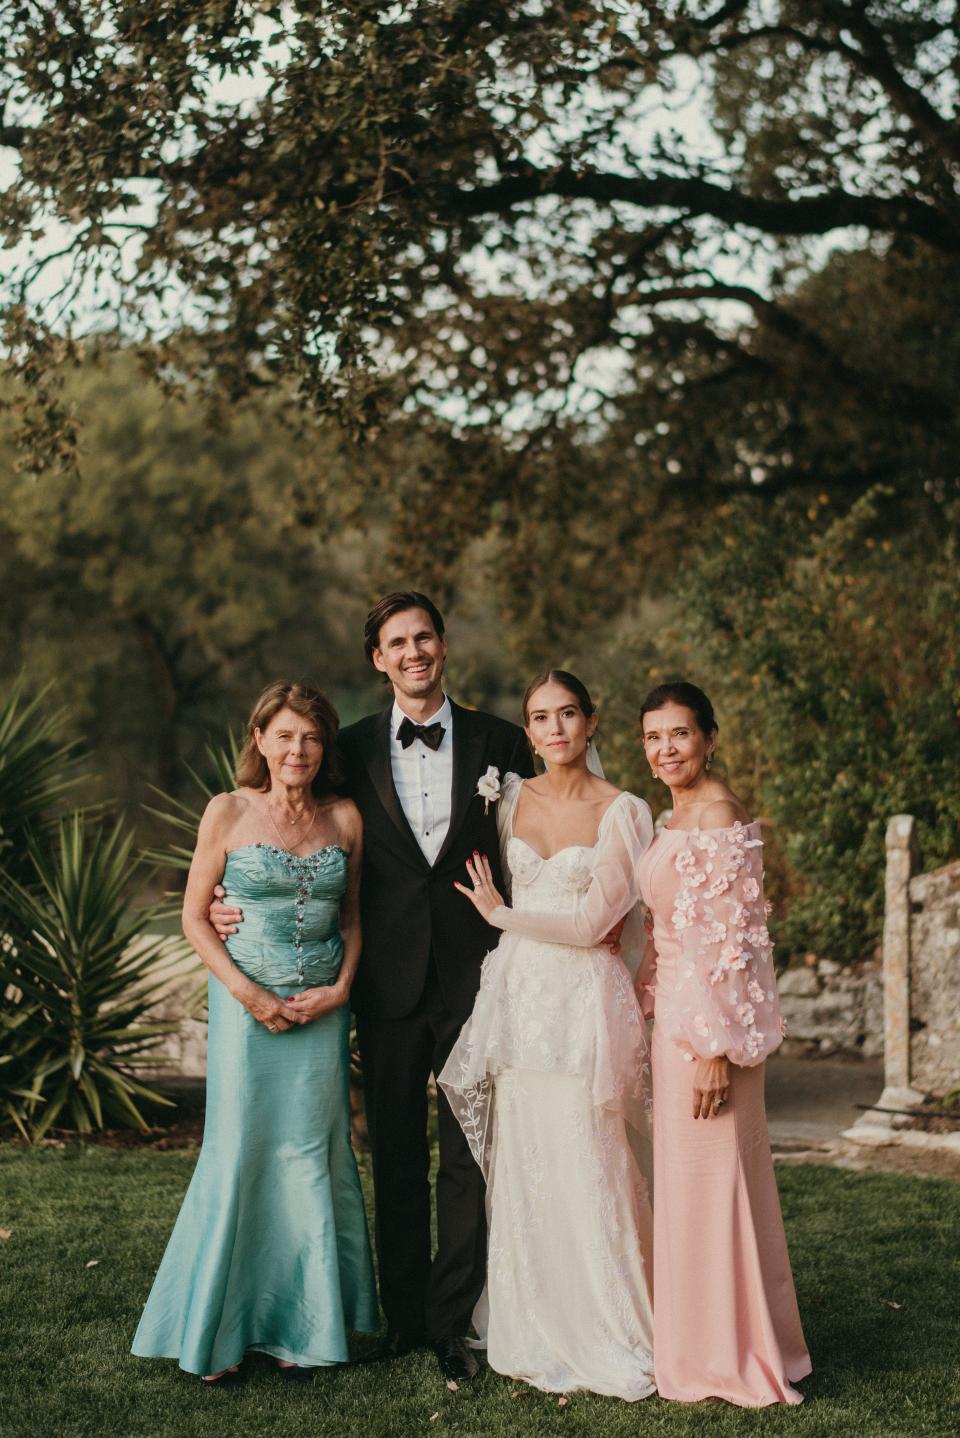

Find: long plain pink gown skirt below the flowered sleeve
[652,1012,811,1408]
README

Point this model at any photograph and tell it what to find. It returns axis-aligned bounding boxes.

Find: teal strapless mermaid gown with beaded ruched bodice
[132,844,378,1373]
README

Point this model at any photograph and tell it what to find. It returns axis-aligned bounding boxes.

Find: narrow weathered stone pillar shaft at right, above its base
[884,814,917,1090]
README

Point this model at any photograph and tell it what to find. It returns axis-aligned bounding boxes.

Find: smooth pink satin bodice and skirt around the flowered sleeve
[640,825,811,1408]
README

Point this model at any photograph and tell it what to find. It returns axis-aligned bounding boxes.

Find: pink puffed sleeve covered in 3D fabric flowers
[670,824,783,1068]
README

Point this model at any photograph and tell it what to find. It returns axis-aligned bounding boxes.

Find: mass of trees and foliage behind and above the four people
[0,0,960,959]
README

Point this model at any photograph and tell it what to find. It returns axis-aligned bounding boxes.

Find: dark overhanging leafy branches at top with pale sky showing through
[0,0,960,454]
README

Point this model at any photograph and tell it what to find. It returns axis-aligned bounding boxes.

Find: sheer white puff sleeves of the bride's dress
[490,794,654,949]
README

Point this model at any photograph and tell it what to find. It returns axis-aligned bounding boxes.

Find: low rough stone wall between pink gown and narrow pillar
[779,959,884,1058]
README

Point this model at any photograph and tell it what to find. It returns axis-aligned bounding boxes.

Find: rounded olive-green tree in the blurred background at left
[0,352,382,805]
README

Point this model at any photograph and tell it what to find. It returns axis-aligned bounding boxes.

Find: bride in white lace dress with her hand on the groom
[438,670,654,1399]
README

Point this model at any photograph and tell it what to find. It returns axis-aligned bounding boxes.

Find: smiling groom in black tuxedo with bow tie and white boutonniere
[341,590,533,1380]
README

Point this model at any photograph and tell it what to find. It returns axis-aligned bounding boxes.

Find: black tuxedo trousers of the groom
[356,963,487,1340]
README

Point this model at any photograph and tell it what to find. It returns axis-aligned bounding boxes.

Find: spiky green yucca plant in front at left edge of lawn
[0,812,183,1139]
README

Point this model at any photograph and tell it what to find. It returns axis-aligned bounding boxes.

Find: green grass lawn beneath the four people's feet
[0,1146,960,1438]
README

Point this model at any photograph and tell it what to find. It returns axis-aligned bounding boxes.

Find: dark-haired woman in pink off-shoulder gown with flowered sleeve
[638,683,811,1408]
